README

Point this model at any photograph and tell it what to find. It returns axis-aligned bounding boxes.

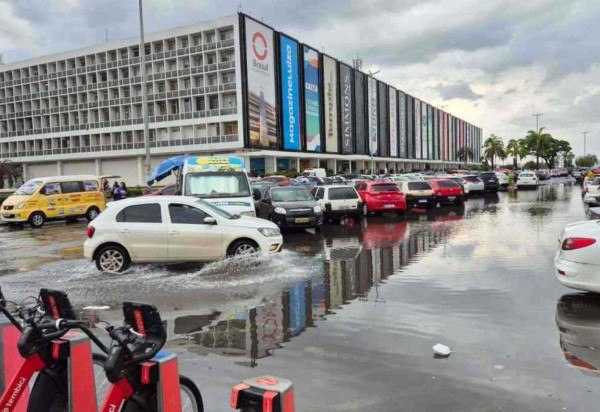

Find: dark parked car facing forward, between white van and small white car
[257,186,323,227]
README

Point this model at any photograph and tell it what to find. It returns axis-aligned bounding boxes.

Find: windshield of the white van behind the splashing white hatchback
[185,172,250,198]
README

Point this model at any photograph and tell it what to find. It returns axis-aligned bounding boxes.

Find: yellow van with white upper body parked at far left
[0,175,106,228]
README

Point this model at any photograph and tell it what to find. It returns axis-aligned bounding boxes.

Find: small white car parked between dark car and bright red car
[311,185,363,219]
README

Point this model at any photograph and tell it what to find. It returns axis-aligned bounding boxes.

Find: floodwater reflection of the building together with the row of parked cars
[169,211,465,367]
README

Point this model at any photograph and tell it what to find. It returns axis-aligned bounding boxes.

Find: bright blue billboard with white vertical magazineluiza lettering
[279,35,302,150]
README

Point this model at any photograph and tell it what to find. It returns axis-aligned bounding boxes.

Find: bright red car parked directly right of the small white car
[356,181,406,216]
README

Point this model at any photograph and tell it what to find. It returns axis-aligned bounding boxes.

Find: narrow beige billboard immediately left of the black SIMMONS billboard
[323,56,339,153]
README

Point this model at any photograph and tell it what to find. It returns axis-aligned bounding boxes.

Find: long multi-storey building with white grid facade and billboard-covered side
[0,14,481,184]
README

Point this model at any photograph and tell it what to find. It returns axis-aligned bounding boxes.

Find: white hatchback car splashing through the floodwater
[83,196,283,273]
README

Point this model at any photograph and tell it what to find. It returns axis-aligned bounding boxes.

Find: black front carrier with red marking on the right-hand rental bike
[123,302,167,362]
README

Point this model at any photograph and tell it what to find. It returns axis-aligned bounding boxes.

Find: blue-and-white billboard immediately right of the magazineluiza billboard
[303,46,322,152]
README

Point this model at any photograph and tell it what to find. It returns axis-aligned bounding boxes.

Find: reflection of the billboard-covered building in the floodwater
[174,222,451,366]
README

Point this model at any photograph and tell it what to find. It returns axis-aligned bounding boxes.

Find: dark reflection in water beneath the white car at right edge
[556,293,600,377]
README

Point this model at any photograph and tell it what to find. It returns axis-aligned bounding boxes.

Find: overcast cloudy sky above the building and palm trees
[0,0,600,155]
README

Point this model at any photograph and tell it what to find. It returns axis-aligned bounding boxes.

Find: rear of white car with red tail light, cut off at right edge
[554,220,600,292]
